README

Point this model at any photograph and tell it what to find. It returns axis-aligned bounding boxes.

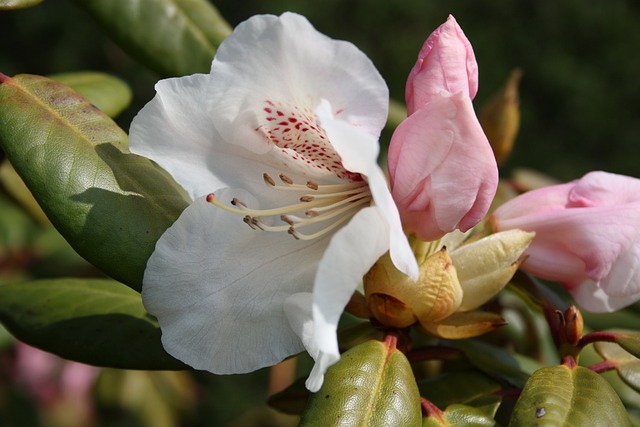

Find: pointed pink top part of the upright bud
[405,15,478,115]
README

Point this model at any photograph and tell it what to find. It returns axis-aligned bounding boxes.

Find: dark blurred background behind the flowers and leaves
[0,0,640,180]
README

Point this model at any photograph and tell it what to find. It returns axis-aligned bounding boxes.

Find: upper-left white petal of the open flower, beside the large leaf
[129,74,278,199]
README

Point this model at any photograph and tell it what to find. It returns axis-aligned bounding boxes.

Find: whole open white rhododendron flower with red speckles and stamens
[130,13,417,391]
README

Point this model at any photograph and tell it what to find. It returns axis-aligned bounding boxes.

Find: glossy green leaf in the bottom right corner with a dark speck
[509,365,631,427]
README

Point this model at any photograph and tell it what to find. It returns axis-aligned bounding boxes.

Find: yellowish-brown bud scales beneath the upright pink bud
[364,230,535,339]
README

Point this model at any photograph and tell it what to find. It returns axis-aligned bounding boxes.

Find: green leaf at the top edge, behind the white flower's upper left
[75,0,231,76]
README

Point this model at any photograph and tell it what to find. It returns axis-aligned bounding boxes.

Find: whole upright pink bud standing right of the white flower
[388,16,498,240]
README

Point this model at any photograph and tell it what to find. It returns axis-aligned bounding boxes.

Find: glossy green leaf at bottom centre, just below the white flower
[300,338,422,427]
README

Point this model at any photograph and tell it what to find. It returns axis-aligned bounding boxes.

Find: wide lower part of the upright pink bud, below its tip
[388,92,498,240]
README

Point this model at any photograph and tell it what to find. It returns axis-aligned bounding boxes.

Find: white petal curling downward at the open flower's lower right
[307,207,389,391]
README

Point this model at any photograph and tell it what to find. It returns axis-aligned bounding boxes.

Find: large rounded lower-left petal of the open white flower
[142,194,329,374]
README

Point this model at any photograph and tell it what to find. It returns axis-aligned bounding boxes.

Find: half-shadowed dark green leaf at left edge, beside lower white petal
[0,279,186,370]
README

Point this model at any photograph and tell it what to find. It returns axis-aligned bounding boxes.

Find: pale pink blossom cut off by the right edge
[491,172,640,312]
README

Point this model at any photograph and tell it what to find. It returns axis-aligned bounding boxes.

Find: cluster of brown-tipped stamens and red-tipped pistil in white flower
[207,173,373,240]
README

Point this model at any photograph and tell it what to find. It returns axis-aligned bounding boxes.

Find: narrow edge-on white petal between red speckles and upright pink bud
[316,100,419,280]
